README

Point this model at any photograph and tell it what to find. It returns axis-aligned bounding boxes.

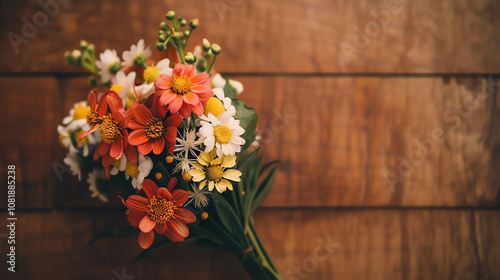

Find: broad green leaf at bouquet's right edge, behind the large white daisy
[231,99,257,150]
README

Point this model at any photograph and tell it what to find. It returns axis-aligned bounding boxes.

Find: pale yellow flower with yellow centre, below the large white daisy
[189,150,241,193]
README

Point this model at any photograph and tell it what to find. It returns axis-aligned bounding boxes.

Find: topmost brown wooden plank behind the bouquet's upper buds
[0,0,500,73]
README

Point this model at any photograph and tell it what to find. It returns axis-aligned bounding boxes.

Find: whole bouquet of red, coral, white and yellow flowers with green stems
[57,11,281,279]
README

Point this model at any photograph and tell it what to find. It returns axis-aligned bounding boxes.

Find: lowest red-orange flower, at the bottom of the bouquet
[122,178,196,249]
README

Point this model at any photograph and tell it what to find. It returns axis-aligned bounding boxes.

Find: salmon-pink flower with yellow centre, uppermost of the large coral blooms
[155,63,214,118]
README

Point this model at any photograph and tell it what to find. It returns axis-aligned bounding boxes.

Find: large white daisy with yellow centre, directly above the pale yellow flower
[198,112,245,158]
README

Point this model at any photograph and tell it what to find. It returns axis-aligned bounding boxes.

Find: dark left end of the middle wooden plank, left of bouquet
[0,77,57,208]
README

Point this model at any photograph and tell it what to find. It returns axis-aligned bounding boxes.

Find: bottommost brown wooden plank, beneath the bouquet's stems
[0,210,494,280]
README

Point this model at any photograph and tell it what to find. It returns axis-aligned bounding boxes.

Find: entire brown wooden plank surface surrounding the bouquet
[0,0,500,280]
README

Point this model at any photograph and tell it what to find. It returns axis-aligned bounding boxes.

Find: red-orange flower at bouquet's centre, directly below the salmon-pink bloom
[127,104,182,155]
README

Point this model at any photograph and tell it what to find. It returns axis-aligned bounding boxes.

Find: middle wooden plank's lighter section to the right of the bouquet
[56,76,500,207]
